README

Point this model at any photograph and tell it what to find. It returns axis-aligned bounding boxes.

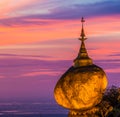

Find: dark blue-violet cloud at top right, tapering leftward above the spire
[39,0,120,20]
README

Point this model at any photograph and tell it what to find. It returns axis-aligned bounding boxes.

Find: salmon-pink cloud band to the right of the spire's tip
[86,15,120,37]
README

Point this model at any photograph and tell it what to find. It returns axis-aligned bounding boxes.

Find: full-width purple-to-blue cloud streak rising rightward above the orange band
[0,0,120,26]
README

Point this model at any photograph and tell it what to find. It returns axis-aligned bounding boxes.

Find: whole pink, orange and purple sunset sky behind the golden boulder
[0,0,120,100]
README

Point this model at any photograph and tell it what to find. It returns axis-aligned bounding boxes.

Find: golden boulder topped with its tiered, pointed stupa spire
[54,18,107,111]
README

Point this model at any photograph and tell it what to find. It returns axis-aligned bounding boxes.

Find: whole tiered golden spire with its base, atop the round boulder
[74,17,92,67]
